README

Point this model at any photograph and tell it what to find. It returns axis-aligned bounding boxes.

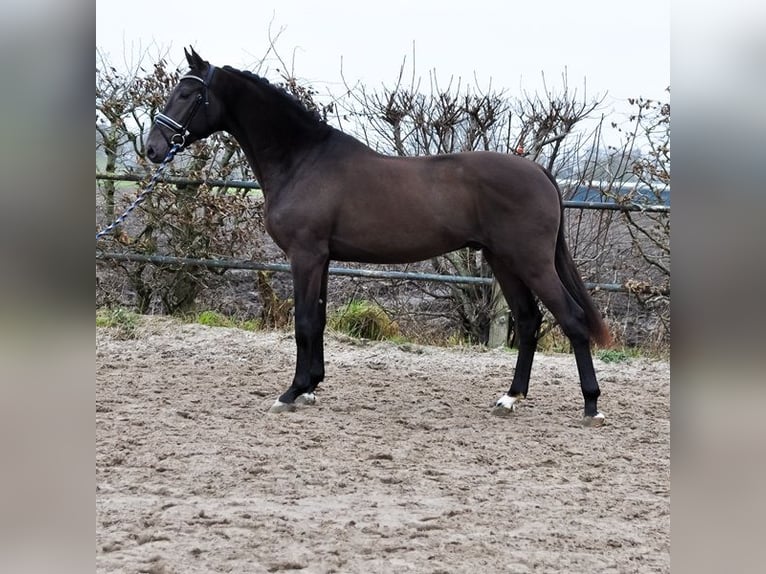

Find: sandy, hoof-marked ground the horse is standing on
[96,318,670,574]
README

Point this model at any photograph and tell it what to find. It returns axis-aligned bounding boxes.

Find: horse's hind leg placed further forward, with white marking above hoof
[484,251,542,416]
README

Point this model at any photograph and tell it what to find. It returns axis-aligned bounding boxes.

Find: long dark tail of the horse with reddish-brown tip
[543,168,612,347]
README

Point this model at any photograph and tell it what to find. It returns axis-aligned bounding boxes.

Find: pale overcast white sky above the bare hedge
[96,0,670,116]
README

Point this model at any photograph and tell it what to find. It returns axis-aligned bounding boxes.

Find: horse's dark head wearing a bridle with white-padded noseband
[146,48,221,163]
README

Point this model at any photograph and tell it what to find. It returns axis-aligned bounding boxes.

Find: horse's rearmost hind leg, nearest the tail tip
[527,263,604,426]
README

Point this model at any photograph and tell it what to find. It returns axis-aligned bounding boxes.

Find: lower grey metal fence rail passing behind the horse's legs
[96,251,670,295]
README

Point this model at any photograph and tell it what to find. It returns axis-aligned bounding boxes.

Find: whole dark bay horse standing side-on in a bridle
[146,50,609,426]
